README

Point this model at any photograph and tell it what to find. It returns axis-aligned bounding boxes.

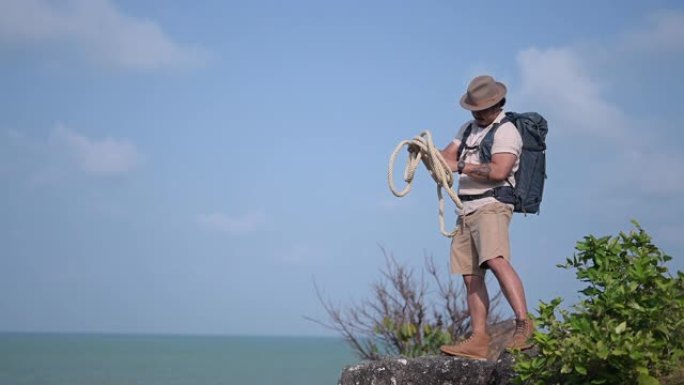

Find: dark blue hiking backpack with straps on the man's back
[458,112,549,214]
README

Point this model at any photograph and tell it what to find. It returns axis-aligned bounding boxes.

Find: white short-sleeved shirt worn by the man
[453,111,522,214]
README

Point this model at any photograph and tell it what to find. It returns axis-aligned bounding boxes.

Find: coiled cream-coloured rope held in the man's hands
[387,131,463,237]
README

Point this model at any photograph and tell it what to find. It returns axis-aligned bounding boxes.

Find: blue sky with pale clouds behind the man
[0,0,684,336]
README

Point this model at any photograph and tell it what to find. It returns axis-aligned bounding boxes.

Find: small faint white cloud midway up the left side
[54,125,140,175]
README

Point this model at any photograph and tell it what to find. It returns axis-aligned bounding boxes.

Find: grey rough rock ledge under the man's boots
[338,352,513,385]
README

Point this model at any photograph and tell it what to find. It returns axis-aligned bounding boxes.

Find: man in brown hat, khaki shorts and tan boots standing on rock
[441,76,534,359]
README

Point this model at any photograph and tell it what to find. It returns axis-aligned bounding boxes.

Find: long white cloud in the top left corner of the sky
[0,0,206,70]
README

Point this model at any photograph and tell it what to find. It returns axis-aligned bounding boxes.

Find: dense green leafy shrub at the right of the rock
[515,222,684,385]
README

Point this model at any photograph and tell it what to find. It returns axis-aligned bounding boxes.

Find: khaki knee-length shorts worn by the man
[451,202,513,276]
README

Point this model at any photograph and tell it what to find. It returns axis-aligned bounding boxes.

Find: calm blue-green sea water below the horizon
[0,333,358,385]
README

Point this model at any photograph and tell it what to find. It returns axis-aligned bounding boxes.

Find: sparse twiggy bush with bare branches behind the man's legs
[307,250,501,360]
